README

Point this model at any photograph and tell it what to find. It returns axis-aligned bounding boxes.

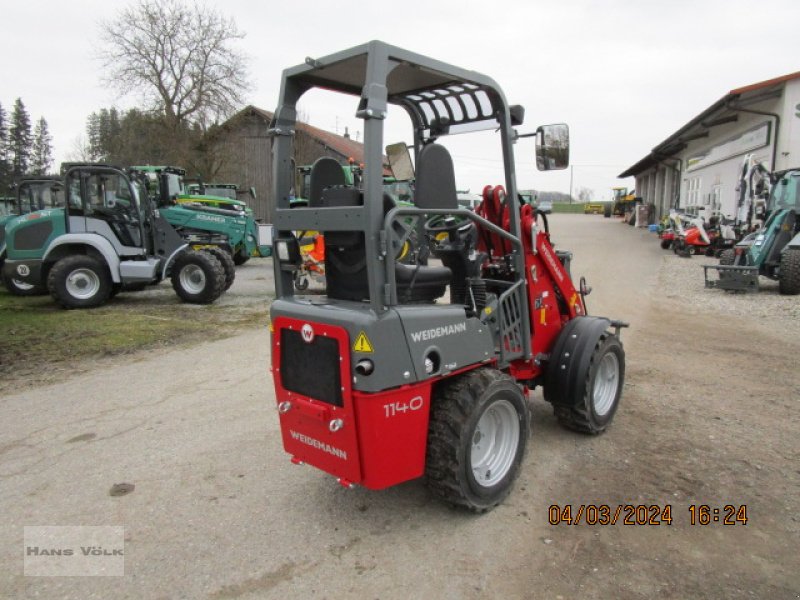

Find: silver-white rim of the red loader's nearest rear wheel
[470,400,520,487]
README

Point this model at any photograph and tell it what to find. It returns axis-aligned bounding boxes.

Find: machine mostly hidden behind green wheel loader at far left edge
[0,175,64,296]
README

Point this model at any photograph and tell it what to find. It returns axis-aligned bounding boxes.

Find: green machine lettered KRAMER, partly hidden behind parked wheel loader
[130,166,272,266]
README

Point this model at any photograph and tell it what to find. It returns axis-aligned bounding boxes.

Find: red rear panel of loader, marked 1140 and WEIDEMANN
[272,317,432,489]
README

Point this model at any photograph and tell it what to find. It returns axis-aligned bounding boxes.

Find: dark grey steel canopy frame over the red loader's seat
[270,41,524,328]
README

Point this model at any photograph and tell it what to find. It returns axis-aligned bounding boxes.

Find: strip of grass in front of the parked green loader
[0,288,267,391]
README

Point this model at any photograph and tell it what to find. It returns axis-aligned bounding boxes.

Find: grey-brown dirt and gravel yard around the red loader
[0,215,800,600]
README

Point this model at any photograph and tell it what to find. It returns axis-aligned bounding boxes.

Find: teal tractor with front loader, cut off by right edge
[704,169,800,295]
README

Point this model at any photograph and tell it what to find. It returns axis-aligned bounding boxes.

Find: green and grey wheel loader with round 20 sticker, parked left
[2,164,227,308]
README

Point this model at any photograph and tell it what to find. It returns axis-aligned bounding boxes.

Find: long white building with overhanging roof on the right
[619,72,800,217]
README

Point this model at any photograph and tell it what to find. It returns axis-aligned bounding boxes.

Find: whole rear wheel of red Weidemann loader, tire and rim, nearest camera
[425,368,530,512]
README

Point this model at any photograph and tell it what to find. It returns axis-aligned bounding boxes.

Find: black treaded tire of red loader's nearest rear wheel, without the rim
[425,368,531,512]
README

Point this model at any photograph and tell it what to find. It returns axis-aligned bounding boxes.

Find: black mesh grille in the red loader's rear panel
[280,329,343,406]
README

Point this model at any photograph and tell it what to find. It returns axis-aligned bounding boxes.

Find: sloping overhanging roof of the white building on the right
[618,71,800,178]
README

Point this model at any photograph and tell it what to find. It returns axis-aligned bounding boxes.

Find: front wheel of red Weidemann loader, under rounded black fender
[554,334,625,434]
